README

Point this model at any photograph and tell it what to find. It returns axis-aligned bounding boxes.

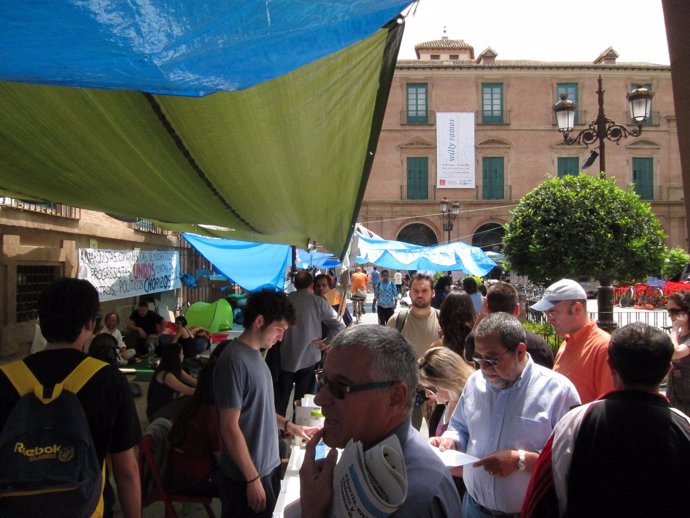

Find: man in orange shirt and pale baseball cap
[531,279,614,403]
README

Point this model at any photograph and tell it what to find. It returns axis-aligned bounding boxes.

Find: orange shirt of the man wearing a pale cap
[553,321,613,403]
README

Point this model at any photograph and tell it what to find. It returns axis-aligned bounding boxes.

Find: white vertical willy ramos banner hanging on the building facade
[436,112,475,189]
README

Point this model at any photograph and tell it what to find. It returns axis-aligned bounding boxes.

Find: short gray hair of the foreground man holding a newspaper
[331,325,418,412]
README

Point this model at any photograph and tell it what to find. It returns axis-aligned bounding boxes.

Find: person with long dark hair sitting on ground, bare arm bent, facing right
[146,343,196,421]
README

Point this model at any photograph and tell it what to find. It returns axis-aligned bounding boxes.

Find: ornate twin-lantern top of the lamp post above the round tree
[553,76,654,175]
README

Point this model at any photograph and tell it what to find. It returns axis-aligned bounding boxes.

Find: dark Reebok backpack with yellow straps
[0,357,106,518]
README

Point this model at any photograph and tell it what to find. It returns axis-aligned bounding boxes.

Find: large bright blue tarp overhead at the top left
[0,0,412,96]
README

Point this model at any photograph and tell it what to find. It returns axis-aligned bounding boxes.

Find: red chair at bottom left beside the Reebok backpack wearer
[139,434,216,518]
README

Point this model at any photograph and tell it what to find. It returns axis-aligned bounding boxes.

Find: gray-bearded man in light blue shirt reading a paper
[429,312,580,518]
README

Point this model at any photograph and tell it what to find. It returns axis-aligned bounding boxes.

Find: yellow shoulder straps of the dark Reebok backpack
[0,356,107,404]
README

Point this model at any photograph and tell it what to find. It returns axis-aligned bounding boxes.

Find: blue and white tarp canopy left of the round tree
[357,232,496,277]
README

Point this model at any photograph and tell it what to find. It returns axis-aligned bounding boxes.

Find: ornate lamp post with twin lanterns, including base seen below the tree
[553,76,654,331]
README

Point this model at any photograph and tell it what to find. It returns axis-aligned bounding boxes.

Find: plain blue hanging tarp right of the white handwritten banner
[182,233,290,291]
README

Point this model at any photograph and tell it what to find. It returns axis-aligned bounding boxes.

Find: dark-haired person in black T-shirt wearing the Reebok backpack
[0,278,141,518]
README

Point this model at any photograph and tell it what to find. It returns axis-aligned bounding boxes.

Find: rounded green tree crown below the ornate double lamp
[504,174,665,284]
